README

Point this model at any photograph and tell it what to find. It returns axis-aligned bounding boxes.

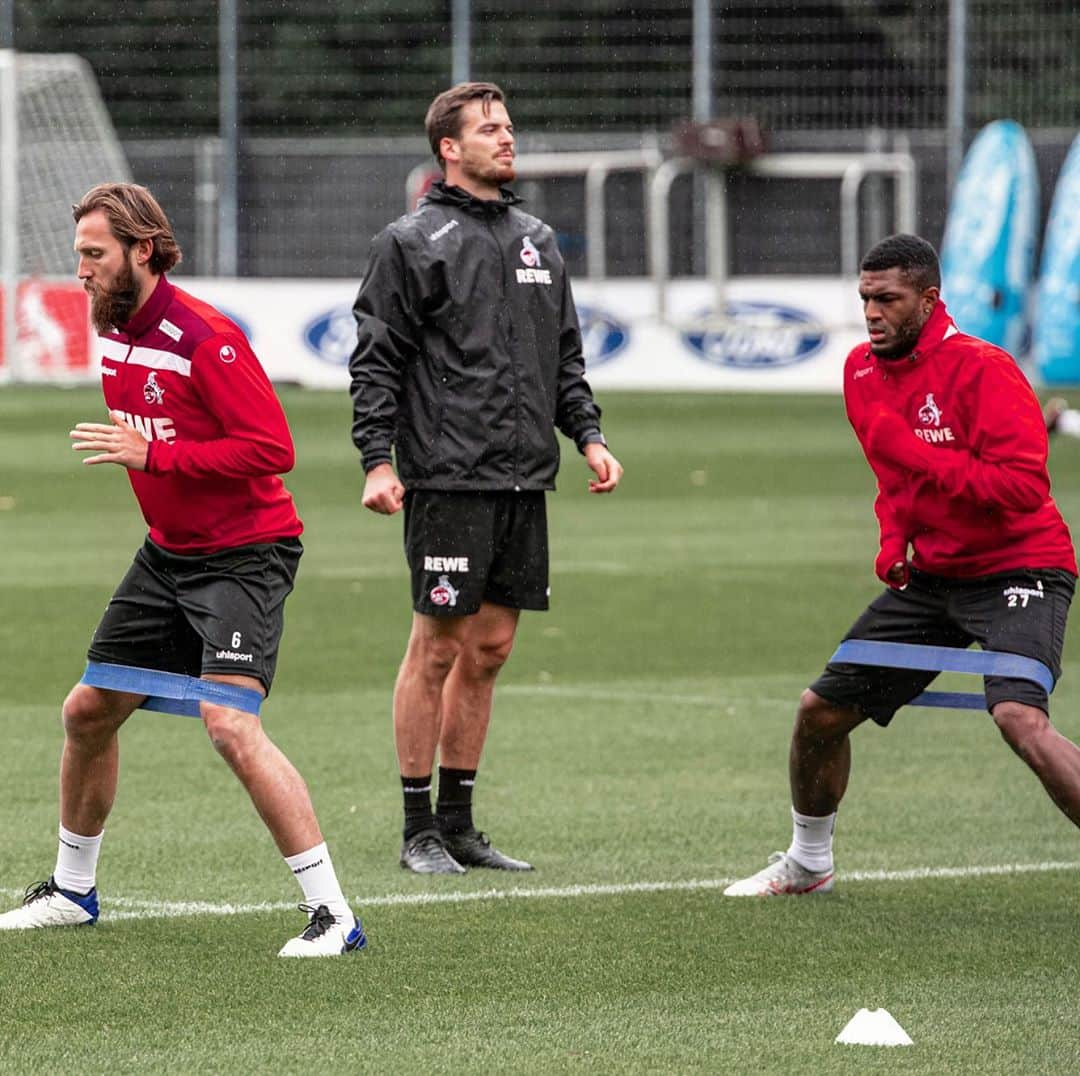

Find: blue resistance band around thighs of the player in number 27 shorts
[828,638,1054,710]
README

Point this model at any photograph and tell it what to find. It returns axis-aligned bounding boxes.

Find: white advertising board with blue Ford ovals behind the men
[168,277,866,392]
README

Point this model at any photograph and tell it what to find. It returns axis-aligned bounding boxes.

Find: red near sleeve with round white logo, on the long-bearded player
[146,333,295,479]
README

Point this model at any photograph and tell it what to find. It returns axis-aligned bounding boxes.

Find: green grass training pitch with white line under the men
[0,389,1080,1074]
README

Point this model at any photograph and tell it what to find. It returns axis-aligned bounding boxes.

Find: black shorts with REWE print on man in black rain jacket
[405,489,548,617]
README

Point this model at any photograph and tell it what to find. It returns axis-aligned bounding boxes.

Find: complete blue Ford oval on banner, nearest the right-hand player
[683,302,828,369]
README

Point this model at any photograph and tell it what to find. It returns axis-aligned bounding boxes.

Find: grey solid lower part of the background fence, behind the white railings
[124,129,1074,279]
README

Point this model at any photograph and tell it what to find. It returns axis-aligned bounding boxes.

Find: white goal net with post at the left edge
[0,50,131,381]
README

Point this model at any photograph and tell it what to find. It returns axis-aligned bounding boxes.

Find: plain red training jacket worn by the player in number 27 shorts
[843,301,1077,578]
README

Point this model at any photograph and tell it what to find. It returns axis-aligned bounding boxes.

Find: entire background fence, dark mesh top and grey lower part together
[13,0,1080,277]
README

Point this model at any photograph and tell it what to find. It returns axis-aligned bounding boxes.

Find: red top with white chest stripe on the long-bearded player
[98,277,303,554]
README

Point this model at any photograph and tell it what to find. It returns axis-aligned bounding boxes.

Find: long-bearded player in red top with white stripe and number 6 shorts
[0,184,365,956]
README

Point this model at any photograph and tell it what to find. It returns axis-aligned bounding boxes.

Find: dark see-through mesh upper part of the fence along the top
[9,0,1080,137]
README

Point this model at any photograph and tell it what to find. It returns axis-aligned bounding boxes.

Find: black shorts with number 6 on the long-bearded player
[87,538,303,691]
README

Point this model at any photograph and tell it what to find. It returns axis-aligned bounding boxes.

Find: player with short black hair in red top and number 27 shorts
[726,236,1080,897]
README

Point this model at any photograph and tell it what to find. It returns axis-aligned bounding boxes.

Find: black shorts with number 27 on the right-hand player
[810,568,1076,725]
